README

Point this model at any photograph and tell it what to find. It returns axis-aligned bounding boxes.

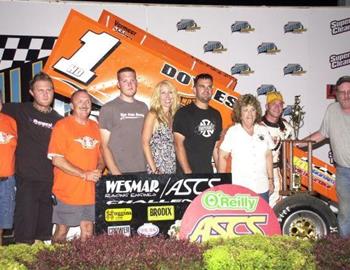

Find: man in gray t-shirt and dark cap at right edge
[305,76,350,237]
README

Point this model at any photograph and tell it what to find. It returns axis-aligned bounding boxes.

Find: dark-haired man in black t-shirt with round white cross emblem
[173,73,222,174]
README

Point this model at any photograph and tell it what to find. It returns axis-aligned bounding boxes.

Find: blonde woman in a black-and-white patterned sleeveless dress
[142,80,179,174]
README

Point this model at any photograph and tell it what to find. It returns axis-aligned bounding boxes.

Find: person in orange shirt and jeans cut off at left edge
[0,91,17,246]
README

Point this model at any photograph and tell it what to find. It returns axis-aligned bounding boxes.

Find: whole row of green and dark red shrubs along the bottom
[0,235,328,270]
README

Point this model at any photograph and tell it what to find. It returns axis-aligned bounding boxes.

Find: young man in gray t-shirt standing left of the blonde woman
[99,67,148,175]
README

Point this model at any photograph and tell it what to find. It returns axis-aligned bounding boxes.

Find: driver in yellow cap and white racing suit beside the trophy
[262,91,293,207]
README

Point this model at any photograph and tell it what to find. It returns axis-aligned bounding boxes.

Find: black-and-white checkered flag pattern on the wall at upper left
[0,35,56,70]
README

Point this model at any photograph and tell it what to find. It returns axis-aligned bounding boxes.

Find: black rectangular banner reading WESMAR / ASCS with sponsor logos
[95,174,231,237]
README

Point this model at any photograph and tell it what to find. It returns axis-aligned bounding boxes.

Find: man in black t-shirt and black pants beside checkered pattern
[2,72,61,244]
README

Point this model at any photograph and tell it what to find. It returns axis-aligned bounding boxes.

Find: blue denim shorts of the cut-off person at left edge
[0,176,16,229]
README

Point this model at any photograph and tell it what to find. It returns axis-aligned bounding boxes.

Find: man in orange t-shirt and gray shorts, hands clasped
[48,90,104,242]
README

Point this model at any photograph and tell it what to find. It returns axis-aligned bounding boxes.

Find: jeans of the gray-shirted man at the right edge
[335,166,350,237]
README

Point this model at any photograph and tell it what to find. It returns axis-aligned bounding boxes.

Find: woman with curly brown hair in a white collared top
[218,94,274,202]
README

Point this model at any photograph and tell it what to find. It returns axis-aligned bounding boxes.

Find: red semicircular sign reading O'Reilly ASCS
[180,185,281,243]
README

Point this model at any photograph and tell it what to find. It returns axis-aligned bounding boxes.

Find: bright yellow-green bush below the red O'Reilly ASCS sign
[204,235,315,270]
